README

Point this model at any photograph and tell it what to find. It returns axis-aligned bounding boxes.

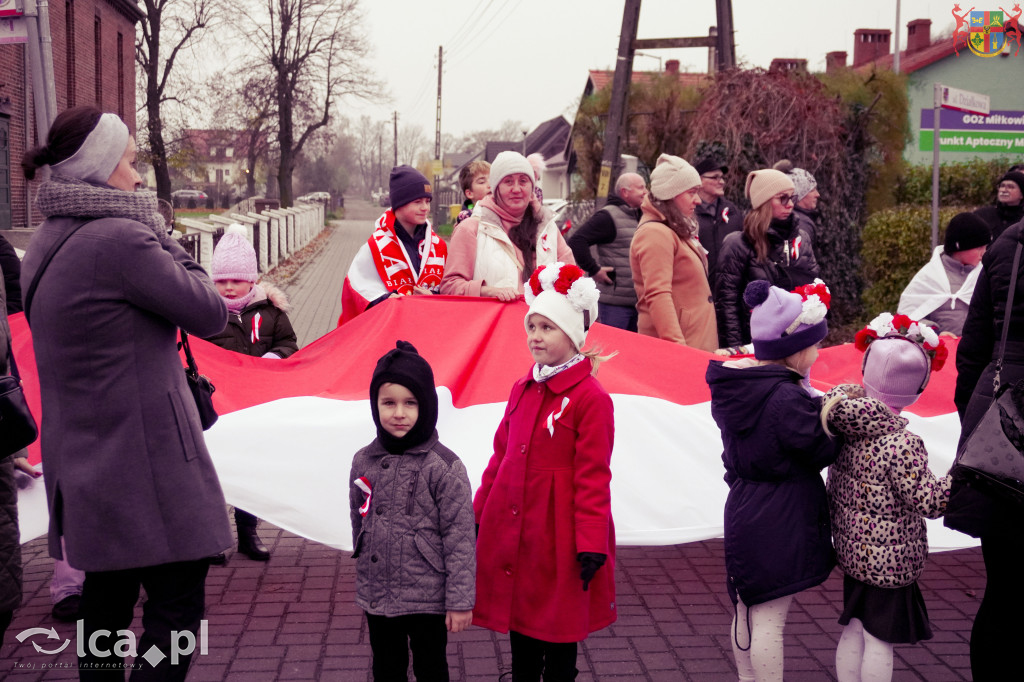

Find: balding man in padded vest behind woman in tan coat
[568,173,647,332]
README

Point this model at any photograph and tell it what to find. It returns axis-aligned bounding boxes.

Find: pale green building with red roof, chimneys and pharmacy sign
[825,18,1024,164]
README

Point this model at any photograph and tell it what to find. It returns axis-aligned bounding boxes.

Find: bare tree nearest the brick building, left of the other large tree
[135,0,215,201]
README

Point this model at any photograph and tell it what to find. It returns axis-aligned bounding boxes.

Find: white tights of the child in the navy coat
[730,595,793,682]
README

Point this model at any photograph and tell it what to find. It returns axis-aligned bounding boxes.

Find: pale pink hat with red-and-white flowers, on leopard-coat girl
[854,312,948,412]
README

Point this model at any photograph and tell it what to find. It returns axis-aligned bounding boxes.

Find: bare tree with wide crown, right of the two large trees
[238,0,374,207]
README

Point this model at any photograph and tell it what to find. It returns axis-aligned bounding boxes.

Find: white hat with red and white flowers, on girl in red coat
[523,262,600,350]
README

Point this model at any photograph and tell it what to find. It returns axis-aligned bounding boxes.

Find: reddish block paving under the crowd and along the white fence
[0,199,984,682]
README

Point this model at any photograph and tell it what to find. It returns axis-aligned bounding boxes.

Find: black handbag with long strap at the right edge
[949,235,1024,507]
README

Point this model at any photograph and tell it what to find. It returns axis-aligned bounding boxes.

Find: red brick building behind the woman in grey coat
[0,0,144,229]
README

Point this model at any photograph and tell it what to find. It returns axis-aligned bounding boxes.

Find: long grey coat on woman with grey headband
[22,217,231,571]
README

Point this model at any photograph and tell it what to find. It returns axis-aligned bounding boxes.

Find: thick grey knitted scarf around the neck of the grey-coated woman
[36,173,167,237]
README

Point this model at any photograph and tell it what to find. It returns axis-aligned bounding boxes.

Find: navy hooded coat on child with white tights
[706,360,840,606]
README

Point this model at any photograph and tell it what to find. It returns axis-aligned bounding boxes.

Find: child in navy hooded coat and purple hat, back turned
[707,280,837,682]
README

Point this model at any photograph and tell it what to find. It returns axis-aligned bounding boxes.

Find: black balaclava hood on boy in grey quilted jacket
[370,341,437,455]
